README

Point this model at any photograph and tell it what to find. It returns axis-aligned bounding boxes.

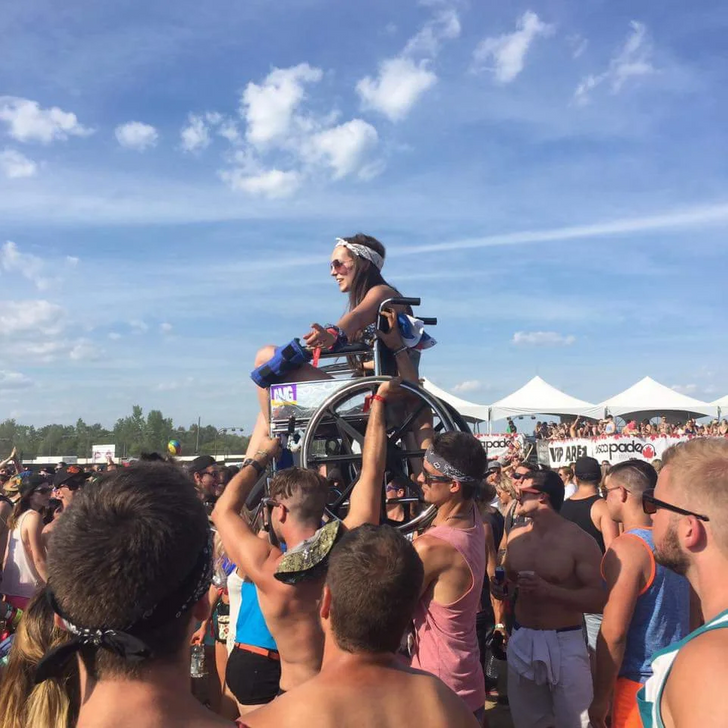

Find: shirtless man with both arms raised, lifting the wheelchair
[212,380,398,693]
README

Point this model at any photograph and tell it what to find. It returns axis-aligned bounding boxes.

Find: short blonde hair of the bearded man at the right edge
[662,437,728,556]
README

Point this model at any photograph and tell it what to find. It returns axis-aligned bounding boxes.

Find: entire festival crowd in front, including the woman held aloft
[0,236,728,728]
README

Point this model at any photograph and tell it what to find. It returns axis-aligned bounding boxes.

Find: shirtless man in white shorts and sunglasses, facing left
[498,471,606,728]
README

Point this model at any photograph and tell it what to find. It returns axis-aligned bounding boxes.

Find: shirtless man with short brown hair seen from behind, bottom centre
[245,525,478,728]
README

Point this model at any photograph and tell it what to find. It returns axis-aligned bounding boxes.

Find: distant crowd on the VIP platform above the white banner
[534,415,728,440]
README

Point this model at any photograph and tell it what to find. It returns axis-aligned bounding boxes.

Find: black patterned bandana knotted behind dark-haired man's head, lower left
[34,535,213,685]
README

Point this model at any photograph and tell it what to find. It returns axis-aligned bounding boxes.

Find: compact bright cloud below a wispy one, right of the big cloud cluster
[356,58,437,121]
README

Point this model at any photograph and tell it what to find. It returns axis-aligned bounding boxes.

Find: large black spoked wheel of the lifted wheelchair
[301,376,460,533]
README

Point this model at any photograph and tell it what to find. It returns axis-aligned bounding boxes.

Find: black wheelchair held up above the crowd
[249,297,470,534]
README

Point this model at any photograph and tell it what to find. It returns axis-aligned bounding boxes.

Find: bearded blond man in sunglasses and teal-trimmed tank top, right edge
[637,437,728,728]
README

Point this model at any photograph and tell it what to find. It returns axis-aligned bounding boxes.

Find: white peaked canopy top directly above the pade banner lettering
[599,377,716,420]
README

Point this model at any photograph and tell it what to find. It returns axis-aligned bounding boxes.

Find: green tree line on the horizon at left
[0,405,249,460]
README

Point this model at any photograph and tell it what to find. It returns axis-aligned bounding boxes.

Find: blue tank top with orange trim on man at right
[619,528,690,683]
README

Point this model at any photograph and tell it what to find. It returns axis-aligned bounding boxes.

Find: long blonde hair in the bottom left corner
[0,590,81,728]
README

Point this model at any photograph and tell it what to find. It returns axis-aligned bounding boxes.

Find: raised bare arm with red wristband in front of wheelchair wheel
[343,379,400,528]
